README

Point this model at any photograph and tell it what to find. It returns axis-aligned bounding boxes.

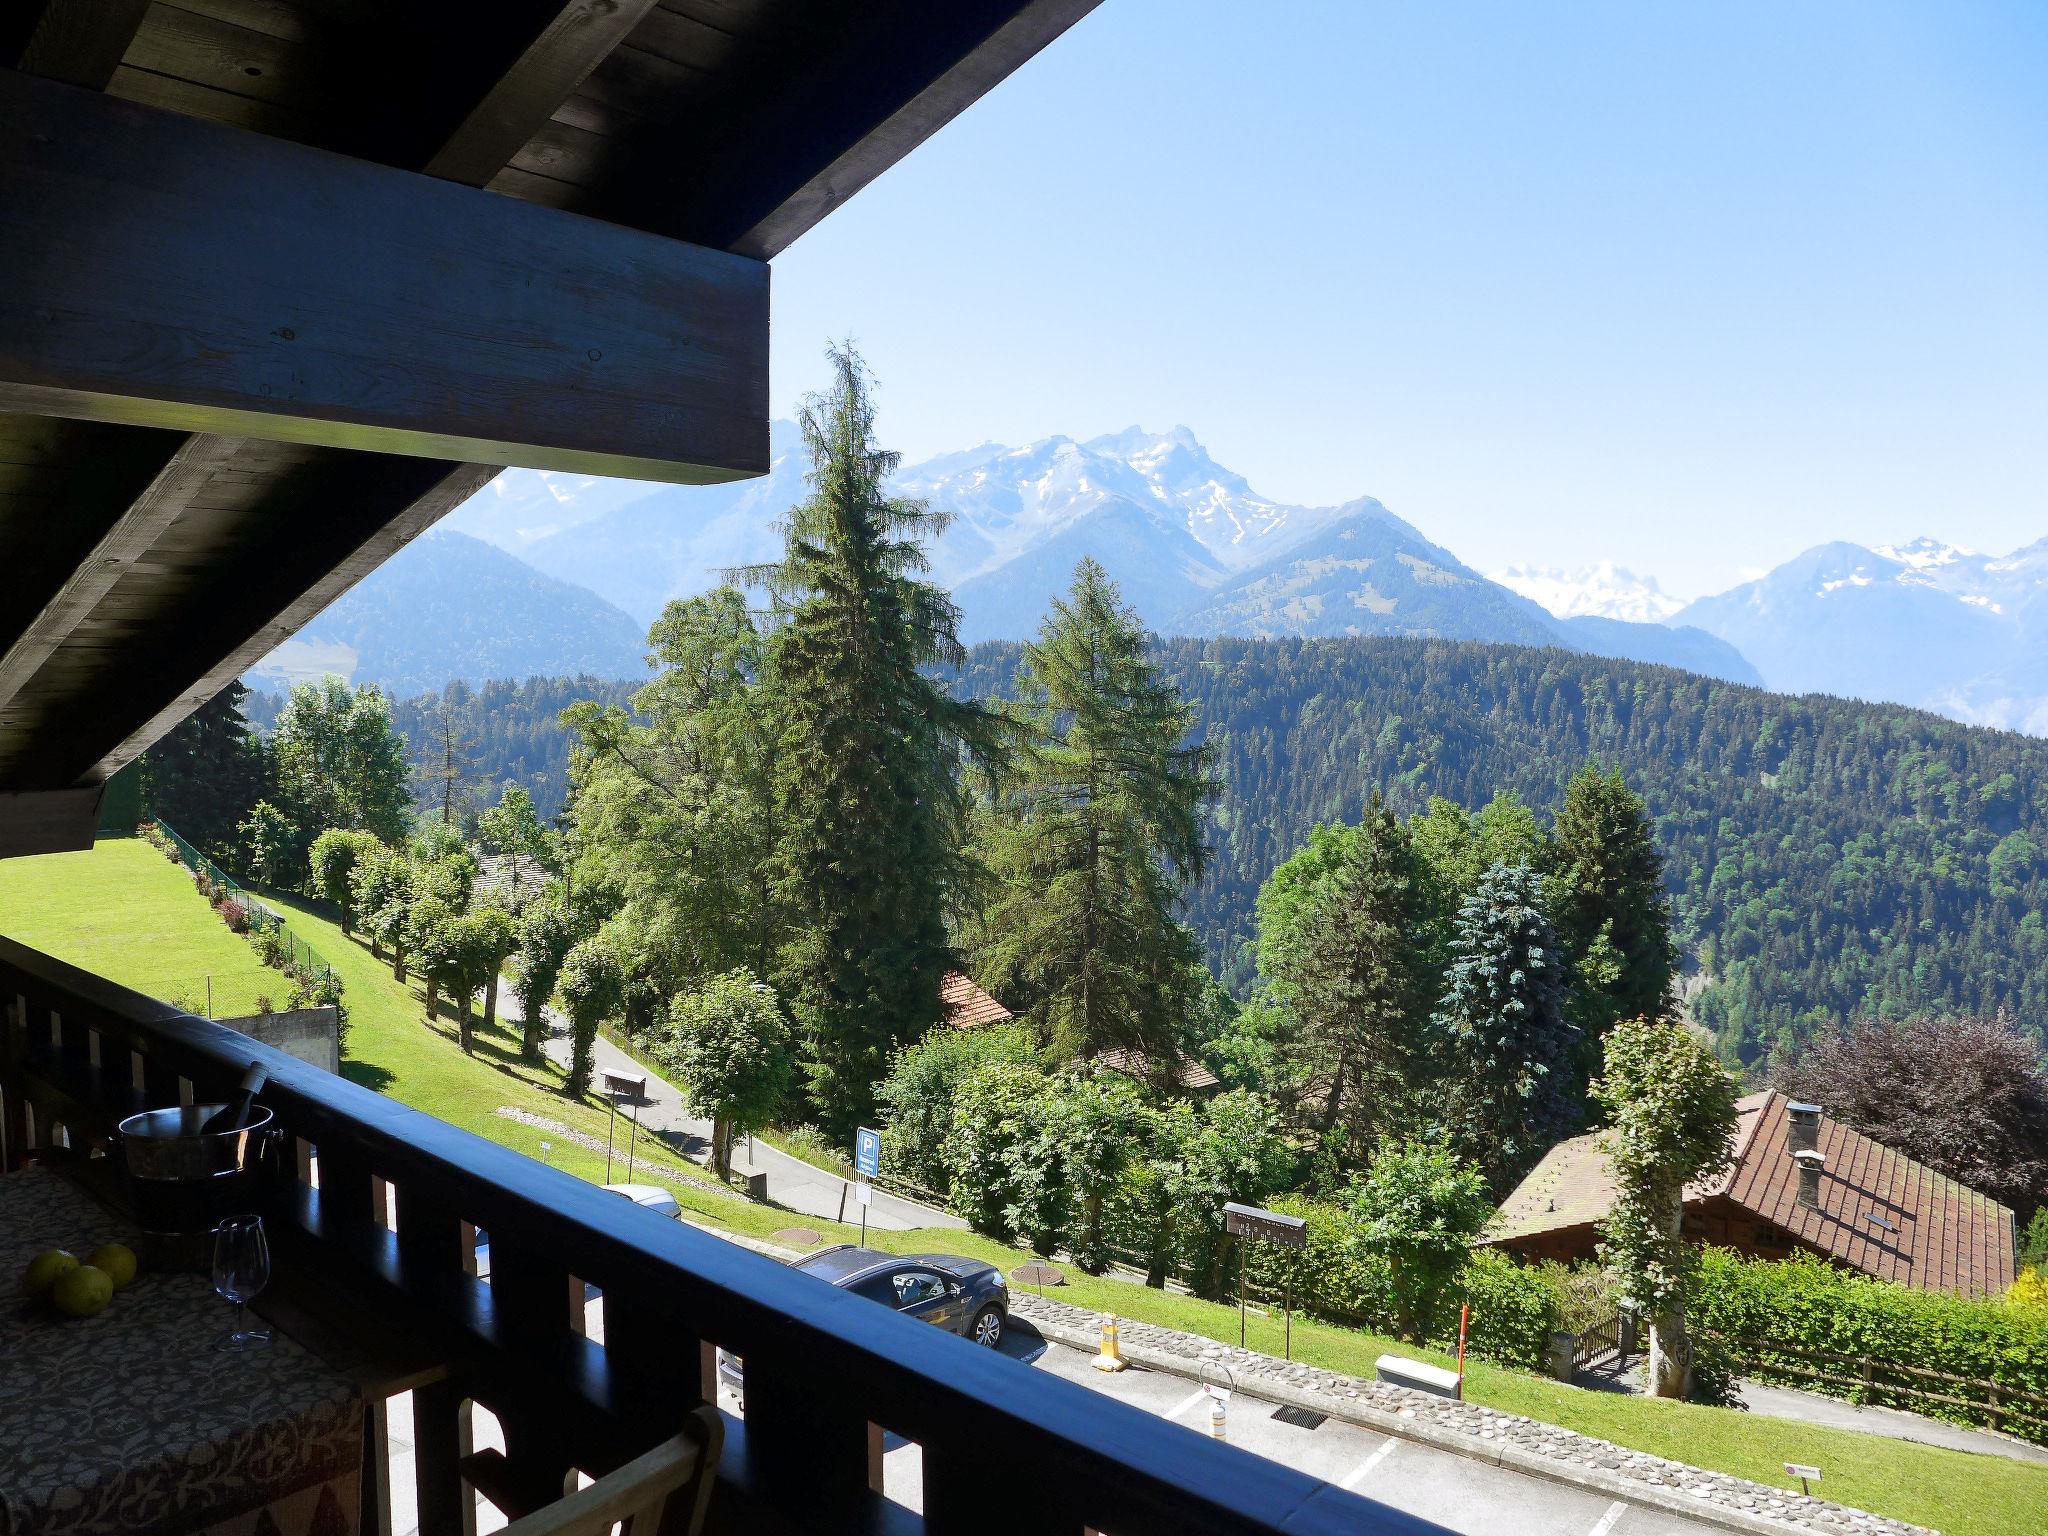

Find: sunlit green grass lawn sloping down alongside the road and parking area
[0,840,2048,1536]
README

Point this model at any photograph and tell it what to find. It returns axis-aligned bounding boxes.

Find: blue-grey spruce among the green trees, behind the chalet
[1434,864,1577,1190]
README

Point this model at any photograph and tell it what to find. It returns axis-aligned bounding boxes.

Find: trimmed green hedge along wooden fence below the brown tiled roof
[1692,1247,2048,1444]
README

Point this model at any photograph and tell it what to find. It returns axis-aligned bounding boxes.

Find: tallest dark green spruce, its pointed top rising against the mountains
[735,348,993,1137]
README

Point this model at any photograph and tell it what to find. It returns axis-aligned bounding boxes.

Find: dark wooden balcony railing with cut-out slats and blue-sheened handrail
[0,938,1436,1536]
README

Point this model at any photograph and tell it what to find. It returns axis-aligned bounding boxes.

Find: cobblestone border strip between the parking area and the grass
[1010,1292,1931,1536]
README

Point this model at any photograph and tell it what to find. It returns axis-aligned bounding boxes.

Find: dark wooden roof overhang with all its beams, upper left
[0,0,1096,854]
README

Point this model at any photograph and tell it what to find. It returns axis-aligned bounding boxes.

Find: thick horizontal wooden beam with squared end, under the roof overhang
[0,74,768,481]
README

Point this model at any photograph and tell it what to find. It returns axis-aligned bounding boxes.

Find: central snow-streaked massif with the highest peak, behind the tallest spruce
[432,422,1757,682]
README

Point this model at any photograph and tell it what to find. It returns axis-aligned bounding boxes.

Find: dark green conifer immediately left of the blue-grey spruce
[1274,795,1436,1159]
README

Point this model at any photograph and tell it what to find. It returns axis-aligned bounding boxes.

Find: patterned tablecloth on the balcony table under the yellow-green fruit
[0,1169,362,1536]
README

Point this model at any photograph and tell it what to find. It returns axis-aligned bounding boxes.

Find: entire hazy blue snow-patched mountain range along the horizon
[264,422,2048,733]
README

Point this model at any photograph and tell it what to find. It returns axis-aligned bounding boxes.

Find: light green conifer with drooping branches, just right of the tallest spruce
[973,559,1219,1077]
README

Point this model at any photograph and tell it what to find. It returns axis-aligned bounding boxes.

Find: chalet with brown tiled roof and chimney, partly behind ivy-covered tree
[1481,1092,2017,1296]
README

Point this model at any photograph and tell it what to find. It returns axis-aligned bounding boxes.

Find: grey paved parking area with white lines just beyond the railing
[719,1323,1722,1536]
